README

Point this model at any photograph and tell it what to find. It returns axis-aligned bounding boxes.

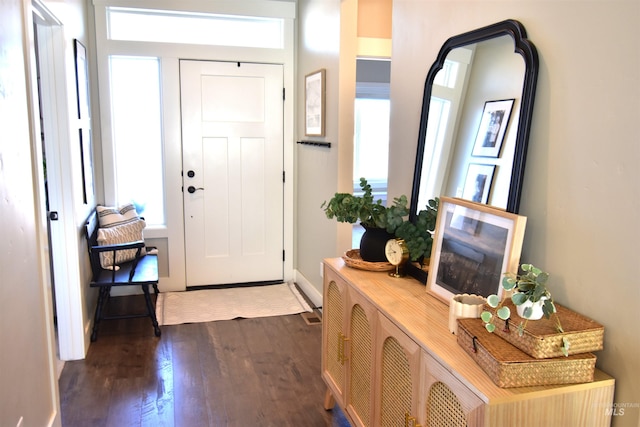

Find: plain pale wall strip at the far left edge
[0,0,60,426]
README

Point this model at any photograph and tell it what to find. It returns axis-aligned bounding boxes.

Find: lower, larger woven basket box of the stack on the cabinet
[458,319,596,388]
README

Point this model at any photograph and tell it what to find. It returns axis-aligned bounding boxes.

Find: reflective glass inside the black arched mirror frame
[417,36,524,210]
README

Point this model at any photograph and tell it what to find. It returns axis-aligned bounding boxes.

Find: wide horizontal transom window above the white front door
[107,7,284,49]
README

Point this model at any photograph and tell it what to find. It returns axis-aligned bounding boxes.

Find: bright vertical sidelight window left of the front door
[109,56,165,225]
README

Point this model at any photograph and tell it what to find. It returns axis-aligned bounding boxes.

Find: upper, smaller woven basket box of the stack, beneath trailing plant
[493,299,604,359]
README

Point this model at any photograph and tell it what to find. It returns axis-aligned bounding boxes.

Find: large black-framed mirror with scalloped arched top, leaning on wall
[409,20,539,281]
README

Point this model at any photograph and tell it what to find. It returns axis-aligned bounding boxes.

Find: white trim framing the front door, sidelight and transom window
[93,0,298,292]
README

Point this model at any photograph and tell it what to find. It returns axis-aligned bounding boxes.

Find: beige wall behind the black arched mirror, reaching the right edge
[389,0,640,426]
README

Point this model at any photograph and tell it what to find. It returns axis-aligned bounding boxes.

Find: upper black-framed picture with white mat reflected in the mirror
[471,98,515,157]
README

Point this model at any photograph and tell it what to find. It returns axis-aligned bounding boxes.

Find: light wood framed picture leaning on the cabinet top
[427,197,527,304]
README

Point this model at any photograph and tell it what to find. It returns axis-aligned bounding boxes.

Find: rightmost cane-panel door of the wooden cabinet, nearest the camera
[421,350,484,427]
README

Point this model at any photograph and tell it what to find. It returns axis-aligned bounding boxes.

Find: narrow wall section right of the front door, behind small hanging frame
[294,0,357,303]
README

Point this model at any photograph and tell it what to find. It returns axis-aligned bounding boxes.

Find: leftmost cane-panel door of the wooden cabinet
[322,268,347,408]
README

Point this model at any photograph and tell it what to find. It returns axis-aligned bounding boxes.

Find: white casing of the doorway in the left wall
[25,0,88,364]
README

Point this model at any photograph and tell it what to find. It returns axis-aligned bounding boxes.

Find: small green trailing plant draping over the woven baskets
[480,264,570,356]
